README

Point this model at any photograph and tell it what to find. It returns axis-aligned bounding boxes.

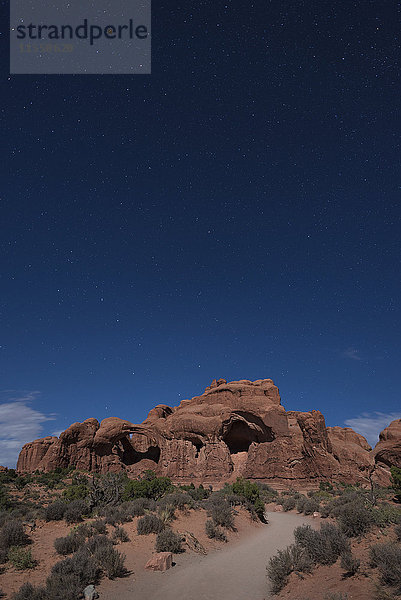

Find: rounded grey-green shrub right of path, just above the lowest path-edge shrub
[294,523,350,565]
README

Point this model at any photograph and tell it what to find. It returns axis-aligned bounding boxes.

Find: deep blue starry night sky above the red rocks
[0,0,401,466]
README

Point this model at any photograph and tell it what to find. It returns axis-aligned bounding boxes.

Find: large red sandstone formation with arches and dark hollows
[17,379,400,485]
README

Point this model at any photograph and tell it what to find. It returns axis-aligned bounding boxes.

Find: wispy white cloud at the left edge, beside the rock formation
[0,391,55,467]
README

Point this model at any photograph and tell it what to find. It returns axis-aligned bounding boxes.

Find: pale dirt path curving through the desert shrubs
[99,513,311,600]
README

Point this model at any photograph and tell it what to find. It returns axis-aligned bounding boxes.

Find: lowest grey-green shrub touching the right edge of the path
[267,544,312,594]
